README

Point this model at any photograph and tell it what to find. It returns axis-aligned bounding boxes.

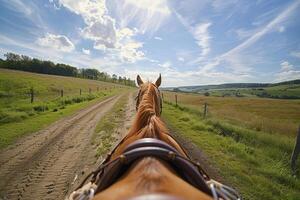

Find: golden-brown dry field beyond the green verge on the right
[163,92,300,137]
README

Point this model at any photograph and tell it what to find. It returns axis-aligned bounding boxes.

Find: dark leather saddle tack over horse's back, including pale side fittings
[73,138,240,200]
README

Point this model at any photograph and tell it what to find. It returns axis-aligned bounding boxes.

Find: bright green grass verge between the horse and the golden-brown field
[163,103,300,200]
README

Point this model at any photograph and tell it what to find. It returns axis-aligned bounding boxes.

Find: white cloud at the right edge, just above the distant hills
[275,61,300,81]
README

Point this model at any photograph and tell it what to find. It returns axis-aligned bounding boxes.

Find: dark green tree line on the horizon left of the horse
[0,52,135,86]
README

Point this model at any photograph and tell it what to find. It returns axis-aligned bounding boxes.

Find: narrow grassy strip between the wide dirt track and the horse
[92,95,128,157]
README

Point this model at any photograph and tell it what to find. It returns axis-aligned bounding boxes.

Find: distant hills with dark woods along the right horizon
[166,80,300,99]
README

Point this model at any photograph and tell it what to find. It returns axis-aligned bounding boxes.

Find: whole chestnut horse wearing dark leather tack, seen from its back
[70,75,238,200]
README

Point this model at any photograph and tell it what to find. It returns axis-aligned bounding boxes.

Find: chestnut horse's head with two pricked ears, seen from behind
[136,74,162,116]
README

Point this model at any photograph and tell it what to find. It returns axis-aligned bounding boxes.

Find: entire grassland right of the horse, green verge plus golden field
[163,92,300,200]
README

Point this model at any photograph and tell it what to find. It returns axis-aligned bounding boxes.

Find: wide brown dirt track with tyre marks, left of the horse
[0,96,120,199]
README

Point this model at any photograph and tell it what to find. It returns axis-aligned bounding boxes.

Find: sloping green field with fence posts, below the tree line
[0,69,130,148]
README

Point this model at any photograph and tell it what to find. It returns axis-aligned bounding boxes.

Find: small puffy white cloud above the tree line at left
[36,33,75,52]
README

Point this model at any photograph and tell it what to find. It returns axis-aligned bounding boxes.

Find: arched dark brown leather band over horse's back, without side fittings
[96,138,211,195]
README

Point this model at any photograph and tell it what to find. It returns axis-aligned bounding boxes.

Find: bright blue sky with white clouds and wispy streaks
[0,0,300,86]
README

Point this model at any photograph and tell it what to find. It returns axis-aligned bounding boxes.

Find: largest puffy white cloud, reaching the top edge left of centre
[59,0,145,63]
